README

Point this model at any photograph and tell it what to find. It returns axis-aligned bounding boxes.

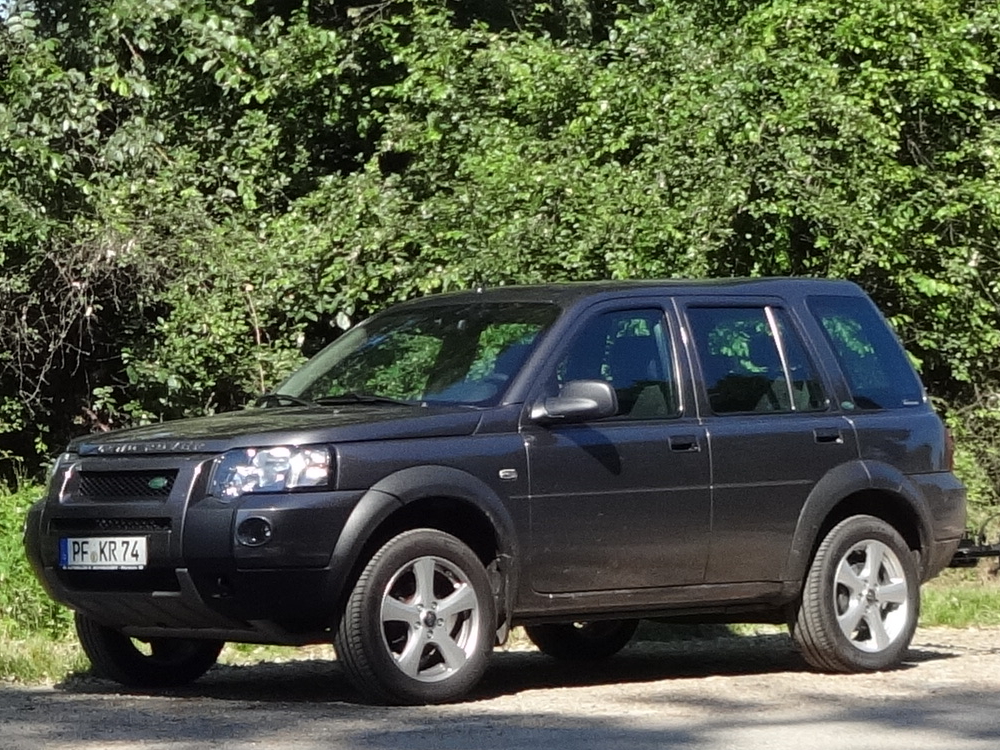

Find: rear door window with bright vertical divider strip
[687,306,827,414]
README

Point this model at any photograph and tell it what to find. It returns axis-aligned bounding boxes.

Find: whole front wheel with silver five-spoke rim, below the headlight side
[334,529,496,705]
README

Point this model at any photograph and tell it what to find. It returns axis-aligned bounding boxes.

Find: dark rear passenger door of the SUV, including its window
[683,298,858,583]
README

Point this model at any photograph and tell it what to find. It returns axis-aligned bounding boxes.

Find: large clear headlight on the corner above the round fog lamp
[209,445,330,500]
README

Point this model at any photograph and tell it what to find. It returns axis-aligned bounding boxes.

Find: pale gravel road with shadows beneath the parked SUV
[0,629,1000,750]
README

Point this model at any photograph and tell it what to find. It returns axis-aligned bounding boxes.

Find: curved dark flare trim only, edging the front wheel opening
[330,465,520,636]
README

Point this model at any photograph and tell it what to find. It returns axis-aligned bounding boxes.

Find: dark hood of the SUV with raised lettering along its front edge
[69,404,482,455]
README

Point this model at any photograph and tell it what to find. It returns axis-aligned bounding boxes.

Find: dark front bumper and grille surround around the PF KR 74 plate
[25,456,362,645]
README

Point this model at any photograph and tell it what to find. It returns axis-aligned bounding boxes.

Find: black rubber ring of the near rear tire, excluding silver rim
[809,516,920,671]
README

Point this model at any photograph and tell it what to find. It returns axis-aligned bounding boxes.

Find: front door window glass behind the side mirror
[554,309,680,419]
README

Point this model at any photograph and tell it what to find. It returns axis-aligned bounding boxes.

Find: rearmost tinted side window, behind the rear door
[808,296,924,409]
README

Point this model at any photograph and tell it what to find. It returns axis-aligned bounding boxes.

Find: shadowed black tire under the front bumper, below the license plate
[76,613,224,687]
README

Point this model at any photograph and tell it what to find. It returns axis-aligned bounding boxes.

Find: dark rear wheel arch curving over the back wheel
[784,461,931,585]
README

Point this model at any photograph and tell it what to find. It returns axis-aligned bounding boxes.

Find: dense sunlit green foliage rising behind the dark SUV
[0,0,1000,512]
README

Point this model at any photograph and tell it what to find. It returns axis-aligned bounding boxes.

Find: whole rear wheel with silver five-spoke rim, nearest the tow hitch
[792,516,920,672]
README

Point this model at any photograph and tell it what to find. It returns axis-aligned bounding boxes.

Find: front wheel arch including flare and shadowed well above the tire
[331,466,518,626]
